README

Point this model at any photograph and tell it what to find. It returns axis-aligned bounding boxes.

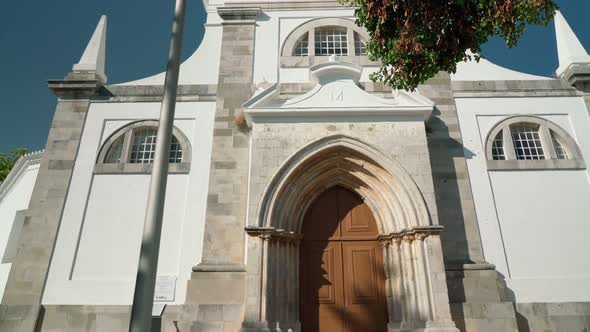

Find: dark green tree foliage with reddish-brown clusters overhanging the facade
[340,0,557,90]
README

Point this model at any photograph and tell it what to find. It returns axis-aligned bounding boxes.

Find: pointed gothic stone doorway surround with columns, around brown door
[242,135,458,332]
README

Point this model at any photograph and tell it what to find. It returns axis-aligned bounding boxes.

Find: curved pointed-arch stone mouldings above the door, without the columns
[258,135,431,235]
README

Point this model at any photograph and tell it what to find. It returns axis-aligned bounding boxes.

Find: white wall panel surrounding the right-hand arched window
[456,97,590,302]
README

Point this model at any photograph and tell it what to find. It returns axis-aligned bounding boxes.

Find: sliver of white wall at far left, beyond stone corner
[0,162,39,299]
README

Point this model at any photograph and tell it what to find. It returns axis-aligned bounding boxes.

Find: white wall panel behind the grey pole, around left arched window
[43,102,215,305]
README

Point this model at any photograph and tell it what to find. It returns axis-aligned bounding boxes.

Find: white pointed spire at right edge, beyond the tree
[555,10,590,76]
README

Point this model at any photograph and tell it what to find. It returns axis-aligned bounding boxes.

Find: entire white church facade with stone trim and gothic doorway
[0,0,590,332]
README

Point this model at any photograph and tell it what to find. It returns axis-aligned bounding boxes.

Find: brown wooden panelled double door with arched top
[299,187,387,332]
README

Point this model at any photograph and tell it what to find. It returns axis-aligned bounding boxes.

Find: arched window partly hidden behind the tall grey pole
[95,120,190,173]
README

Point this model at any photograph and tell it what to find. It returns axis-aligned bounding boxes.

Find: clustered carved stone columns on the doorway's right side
[380,226,457,332]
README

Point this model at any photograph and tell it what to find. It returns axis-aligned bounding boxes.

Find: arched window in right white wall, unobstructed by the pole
[486,116,586,170]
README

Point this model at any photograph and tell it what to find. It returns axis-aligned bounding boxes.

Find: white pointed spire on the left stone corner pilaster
[72,15,107,82]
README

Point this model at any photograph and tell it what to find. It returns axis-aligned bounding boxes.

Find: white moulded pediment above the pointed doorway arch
[244,62,434,122]
